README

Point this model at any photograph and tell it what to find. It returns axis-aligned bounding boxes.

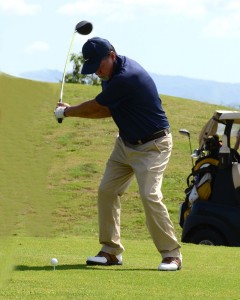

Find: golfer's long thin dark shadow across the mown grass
[14,264,158,272]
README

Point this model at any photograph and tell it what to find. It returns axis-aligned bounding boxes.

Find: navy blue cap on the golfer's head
[81,37,113,74]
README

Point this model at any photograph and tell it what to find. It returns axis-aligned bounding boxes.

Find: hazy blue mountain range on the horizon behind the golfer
[19,69,240,109]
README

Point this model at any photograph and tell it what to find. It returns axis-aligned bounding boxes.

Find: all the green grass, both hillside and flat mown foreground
[0,75,240,299]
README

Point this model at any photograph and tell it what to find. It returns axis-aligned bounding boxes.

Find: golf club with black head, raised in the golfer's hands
[58,21,93,123]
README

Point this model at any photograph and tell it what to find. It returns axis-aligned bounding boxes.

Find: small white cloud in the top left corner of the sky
[0,0,41,16]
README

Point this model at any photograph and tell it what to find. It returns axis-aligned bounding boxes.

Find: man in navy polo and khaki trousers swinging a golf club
[54,37,182,271]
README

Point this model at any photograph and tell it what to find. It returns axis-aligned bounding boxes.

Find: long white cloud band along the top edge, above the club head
[58,0,240,19]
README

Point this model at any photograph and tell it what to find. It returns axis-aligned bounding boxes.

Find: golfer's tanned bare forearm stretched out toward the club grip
[59,99,111,119]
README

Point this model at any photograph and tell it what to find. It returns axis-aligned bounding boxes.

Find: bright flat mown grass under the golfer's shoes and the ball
[0,236,240,300]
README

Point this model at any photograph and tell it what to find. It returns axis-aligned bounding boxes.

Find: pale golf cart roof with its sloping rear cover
[199,110,240,148]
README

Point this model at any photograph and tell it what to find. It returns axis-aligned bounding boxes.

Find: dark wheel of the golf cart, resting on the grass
[188,228,226,246]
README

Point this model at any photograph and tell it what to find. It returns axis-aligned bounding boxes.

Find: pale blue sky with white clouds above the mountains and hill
[0,0,240,83]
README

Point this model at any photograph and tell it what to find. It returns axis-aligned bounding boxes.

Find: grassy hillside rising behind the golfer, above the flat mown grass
[0,74,231,239]
